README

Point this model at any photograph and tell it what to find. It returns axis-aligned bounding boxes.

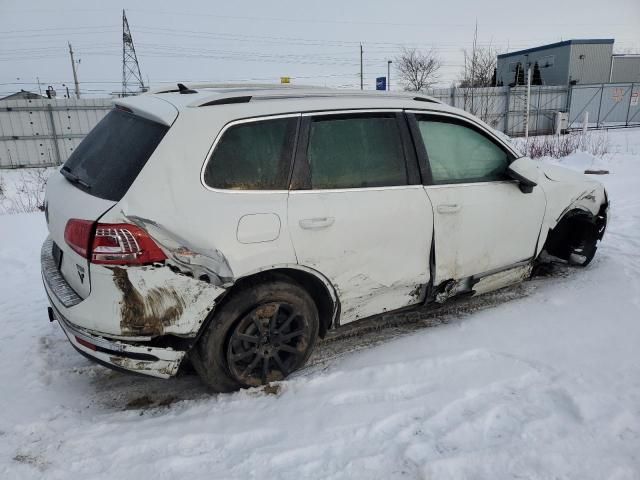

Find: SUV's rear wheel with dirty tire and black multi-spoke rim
[191,277,319,392]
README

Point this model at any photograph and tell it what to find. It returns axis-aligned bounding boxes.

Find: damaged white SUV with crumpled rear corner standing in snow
[42,85,608,391]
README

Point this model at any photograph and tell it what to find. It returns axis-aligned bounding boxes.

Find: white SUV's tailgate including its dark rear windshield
[45,106,175,298]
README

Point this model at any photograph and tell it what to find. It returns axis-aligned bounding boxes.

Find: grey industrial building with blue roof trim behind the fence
[496,38,640,86]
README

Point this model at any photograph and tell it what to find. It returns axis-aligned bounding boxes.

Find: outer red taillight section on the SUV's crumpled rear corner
[91,223,167,265]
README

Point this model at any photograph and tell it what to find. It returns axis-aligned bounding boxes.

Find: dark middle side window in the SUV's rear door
[307,114,407,189]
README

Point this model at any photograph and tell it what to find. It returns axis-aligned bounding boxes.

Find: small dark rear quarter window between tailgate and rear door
[204,117,298,190]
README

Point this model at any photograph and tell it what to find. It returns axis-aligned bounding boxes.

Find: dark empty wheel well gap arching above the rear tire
[212,268,339,338]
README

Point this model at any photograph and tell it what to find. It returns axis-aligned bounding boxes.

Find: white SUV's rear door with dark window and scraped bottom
[288,111,433,324]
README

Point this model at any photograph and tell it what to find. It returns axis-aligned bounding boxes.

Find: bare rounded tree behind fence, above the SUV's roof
[394,48,442,92]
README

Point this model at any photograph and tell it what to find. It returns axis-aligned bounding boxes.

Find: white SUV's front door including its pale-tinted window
[408,112,546,285]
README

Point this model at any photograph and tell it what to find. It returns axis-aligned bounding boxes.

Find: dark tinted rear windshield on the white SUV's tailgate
[61,109,169,202]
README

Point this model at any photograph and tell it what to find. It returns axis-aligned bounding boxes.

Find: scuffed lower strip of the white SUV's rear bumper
[49,302,186,378]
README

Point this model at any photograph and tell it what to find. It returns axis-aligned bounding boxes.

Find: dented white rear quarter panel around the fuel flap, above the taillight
[102,105,296,278]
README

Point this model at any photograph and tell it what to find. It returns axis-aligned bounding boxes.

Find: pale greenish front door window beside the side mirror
[418,117,510,184]
